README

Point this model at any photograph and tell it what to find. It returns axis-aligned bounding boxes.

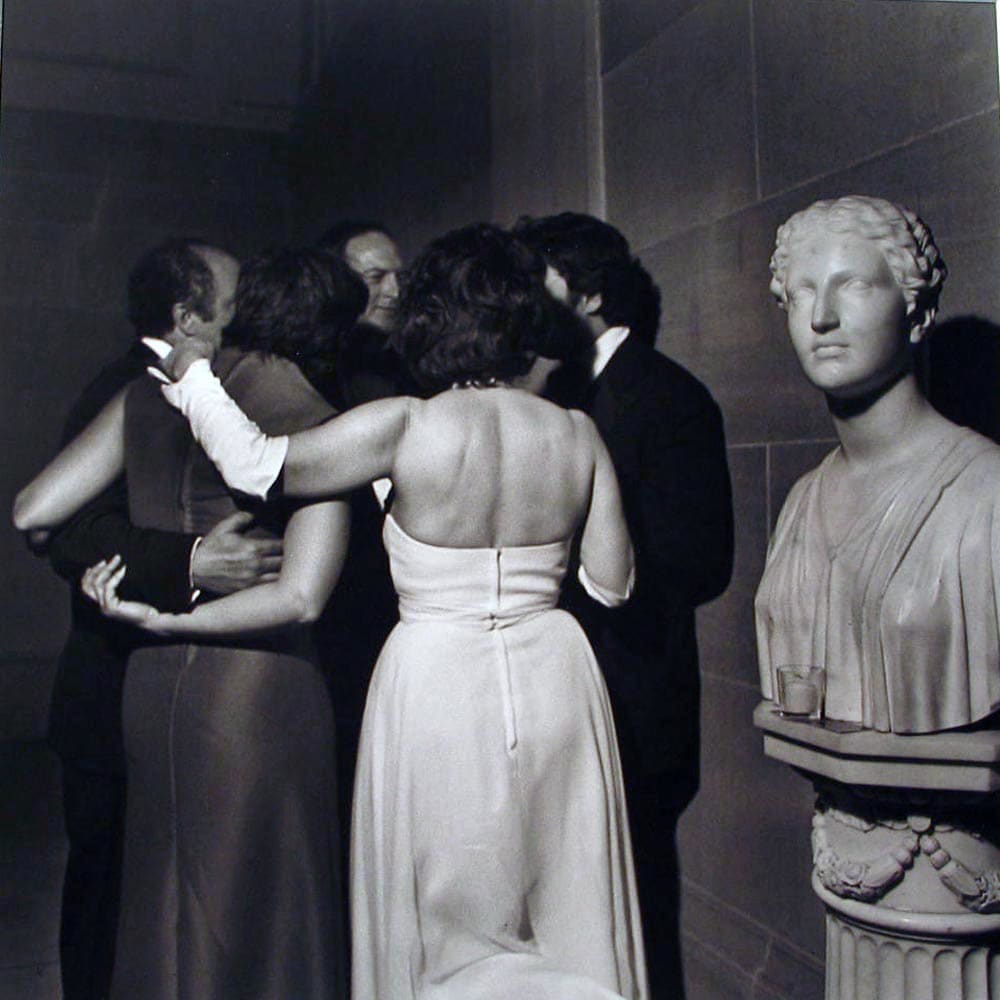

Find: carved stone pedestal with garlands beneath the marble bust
[754,702,1000,1000]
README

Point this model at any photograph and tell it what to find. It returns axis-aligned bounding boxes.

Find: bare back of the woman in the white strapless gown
[392,387,595,548]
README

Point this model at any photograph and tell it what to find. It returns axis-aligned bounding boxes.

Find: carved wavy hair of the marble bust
[771,195,948,341]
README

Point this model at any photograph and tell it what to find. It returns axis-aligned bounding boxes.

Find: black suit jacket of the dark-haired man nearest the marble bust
[549,335,733,799]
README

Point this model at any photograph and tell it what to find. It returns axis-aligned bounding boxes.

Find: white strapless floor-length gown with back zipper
[352,515,646,1000]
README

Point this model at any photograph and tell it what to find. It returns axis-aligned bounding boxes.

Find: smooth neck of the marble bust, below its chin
[827,371,946,472]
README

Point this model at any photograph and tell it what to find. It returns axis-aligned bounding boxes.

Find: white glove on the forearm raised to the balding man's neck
[160,359,288,499]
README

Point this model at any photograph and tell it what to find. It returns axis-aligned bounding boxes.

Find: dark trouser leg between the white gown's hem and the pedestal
[626,775,689,1000]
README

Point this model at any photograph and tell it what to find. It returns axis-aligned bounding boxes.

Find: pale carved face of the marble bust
[785,227,910,398]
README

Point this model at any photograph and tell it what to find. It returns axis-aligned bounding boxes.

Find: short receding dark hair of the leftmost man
[128,236,220,337]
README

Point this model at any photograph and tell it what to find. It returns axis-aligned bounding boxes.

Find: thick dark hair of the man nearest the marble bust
[513,212,660,344]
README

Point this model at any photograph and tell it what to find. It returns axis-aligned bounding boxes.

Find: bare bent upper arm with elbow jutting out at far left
[14,389,127,531]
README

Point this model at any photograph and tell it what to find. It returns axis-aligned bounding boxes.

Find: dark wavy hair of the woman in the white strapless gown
[394,223,548,391]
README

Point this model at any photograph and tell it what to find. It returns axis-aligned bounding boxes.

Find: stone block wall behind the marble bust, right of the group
[493,0,1000,1000]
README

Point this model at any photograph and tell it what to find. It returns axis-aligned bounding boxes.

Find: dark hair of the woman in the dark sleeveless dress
[225,247,368,376]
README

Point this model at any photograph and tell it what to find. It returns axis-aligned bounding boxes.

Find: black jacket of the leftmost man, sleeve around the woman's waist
[48,344,195,773]
